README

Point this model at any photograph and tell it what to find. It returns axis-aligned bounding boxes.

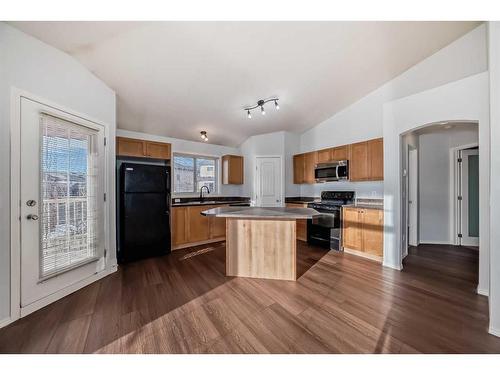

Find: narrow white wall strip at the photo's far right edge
[488,22,500,336]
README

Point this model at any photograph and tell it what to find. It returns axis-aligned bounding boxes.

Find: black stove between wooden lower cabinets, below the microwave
[307,191,355,251]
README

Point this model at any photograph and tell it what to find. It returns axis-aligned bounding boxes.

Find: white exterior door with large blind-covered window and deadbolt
[20,98,105,309]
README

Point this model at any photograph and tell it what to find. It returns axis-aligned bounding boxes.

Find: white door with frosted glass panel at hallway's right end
[458,148,479,246]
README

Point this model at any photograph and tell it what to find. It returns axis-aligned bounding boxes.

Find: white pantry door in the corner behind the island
[256,157,282,207]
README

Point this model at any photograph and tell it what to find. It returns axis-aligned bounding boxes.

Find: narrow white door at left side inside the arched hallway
[408,149,418,246]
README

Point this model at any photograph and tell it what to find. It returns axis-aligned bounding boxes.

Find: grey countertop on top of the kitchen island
[201,207,320,220]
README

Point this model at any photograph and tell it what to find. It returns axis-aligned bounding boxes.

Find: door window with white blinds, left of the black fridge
[40,114,105,279]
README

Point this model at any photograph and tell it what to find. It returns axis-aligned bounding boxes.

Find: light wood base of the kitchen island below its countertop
[226,218,297,280]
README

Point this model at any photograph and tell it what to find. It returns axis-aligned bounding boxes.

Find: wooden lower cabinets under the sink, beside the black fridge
[171,205,226,250]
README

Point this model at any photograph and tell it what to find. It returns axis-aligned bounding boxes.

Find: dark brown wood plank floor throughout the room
[0,241,500,353]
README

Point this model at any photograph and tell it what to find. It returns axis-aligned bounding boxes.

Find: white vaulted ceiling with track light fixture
[11,22,478,146]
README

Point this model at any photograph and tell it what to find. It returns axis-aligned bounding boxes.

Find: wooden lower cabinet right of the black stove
[342,207,384,261]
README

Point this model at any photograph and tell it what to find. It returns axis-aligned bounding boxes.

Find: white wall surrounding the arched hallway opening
[384,72,490,294]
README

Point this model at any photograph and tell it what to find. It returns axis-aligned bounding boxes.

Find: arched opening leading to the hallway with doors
[401,121,480,284]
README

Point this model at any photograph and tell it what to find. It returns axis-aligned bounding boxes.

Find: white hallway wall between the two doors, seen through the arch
[418,124,481,244]
